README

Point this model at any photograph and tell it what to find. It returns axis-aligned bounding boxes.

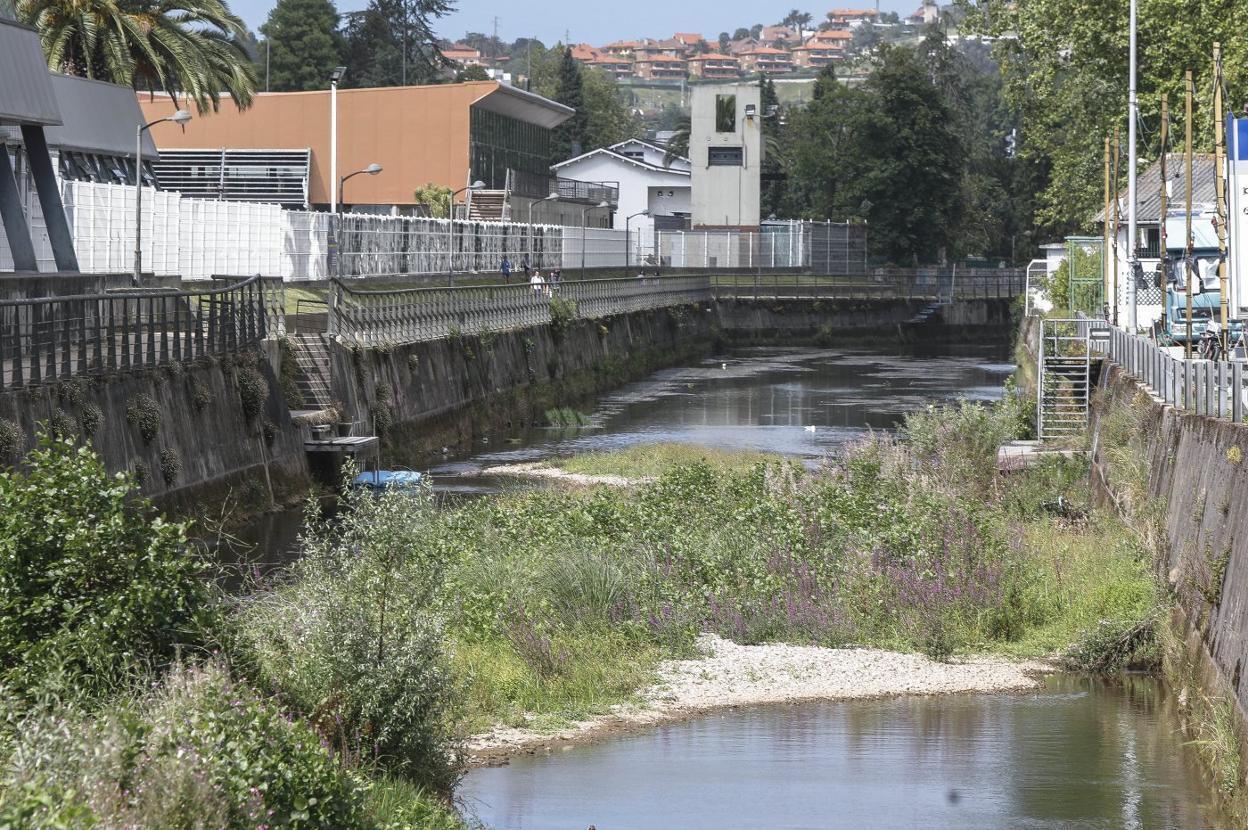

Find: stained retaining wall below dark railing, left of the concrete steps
[0,344,308,515]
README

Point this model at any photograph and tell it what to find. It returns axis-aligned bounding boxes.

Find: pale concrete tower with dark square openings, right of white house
[689,82,764,230]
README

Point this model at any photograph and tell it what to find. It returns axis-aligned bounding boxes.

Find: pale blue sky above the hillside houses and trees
[230,0,922,46]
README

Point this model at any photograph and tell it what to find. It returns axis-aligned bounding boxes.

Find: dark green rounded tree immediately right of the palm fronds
[260,0,342,92]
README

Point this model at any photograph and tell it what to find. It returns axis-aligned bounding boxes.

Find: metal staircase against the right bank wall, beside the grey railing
[1036,320,1092,441]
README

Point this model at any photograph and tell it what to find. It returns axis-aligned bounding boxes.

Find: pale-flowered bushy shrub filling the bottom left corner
[0,666,373,830]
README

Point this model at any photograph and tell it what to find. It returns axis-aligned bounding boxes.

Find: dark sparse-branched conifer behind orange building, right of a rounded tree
[346,0,454,89]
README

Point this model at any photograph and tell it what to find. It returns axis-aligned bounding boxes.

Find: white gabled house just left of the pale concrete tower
[554,139,693,252]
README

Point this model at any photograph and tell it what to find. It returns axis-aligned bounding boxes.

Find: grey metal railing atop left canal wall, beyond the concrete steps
[329,276,710,347]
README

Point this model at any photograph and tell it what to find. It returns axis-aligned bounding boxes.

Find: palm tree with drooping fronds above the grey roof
[16,0,256,112]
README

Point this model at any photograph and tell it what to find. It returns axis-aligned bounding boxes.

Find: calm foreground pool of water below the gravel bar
[461,676,1219,830]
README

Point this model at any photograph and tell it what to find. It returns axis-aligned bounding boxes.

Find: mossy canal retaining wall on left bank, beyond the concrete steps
[331,305,715,466]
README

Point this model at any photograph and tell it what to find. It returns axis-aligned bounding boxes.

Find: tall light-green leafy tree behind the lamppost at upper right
[965,0,1248,236]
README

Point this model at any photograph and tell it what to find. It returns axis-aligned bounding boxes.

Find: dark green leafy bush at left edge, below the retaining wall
[0,434,212,695]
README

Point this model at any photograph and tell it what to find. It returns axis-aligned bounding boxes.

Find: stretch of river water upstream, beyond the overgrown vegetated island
[431,348,1013,489]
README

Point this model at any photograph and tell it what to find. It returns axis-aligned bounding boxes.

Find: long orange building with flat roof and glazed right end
[139,81,573,207]
